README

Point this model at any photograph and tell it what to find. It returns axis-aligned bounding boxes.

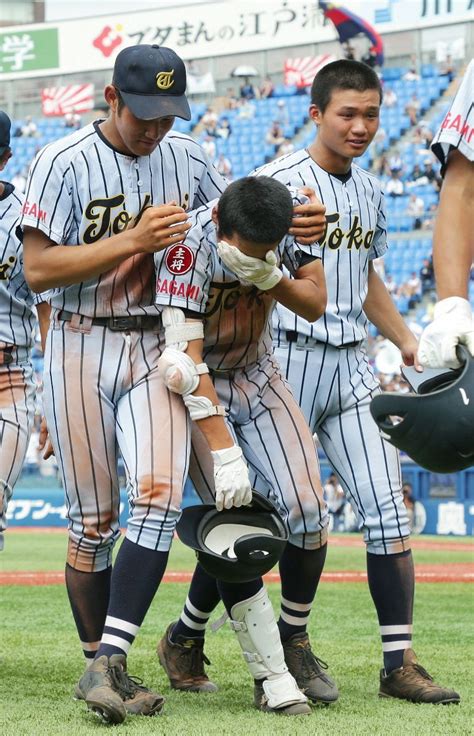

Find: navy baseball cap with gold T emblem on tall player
[112,44,191,120]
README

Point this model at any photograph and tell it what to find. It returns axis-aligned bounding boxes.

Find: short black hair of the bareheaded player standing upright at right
[311,59,383,112]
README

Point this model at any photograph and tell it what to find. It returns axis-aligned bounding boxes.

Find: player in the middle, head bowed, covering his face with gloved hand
[155,177,328,714]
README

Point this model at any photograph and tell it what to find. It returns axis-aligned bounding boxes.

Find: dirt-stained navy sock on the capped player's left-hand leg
[66,564,112,660]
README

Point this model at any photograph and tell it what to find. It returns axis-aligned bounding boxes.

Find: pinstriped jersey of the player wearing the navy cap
[22,121,225,317]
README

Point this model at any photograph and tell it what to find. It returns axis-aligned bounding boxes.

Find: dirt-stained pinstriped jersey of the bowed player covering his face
[155,198,320,371]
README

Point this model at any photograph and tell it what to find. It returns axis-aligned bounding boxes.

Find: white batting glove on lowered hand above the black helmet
[211,445,252,511]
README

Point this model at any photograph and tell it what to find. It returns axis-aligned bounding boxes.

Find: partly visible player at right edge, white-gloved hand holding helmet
[418,60,474,368]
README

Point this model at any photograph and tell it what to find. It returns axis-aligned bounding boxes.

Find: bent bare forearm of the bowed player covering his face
[269,259,327,322]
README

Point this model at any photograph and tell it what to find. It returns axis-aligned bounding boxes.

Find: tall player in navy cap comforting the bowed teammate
[23,45,326,722]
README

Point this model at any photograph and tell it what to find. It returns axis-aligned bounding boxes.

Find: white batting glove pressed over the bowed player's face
[217,240,283,291]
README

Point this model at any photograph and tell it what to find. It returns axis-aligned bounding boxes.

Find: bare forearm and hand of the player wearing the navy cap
[23,205,189,292]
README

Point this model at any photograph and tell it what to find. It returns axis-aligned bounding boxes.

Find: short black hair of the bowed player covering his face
[217,176,293,245]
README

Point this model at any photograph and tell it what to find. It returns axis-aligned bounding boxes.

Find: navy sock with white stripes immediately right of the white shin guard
[278,544,327,642]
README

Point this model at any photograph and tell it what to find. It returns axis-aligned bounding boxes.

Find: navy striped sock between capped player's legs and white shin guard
[170,563,221,643]
